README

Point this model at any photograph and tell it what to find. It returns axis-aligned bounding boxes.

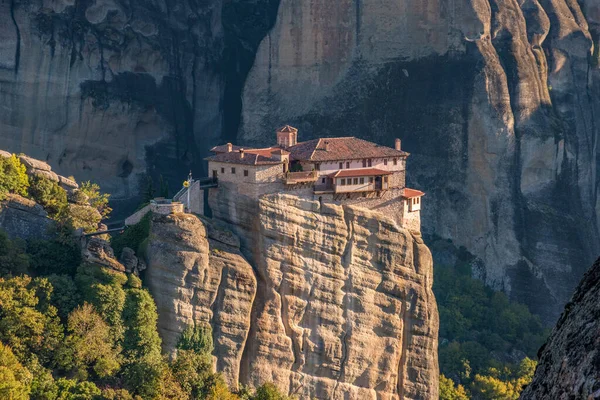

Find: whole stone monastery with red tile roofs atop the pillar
[206,125,424,231]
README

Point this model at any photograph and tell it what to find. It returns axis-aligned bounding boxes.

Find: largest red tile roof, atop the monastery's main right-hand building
[287,137,409,161]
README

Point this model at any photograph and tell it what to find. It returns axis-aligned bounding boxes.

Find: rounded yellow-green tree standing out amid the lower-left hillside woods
[59,303,120,380]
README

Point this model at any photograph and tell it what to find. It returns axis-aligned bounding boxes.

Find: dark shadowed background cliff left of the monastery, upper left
[0,0,276,217]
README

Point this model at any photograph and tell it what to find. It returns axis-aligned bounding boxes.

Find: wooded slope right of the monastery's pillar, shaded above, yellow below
[433,239,549,400]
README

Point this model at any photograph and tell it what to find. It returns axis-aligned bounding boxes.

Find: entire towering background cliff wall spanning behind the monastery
[0,0,600,321]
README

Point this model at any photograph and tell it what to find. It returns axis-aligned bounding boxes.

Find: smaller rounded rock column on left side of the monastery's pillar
[145,214,257,387]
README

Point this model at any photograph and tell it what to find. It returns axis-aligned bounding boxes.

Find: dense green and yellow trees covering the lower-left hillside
[0,231,287,400]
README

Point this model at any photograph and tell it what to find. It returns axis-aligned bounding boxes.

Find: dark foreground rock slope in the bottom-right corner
[520,259,600,400]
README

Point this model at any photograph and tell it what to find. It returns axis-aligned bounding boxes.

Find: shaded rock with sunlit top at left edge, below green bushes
[0,194,54,240]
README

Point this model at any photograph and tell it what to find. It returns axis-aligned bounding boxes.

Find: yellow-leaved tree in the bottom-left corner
[0,342,32,400]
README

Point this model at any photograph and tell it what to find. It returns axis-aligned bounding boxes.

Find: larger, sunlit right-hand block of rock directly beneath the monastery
[242,195,438,400]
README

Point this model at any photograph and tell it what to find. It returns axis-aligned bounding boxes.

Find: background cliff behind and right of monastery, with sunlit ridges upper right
[240,0,600,321]
